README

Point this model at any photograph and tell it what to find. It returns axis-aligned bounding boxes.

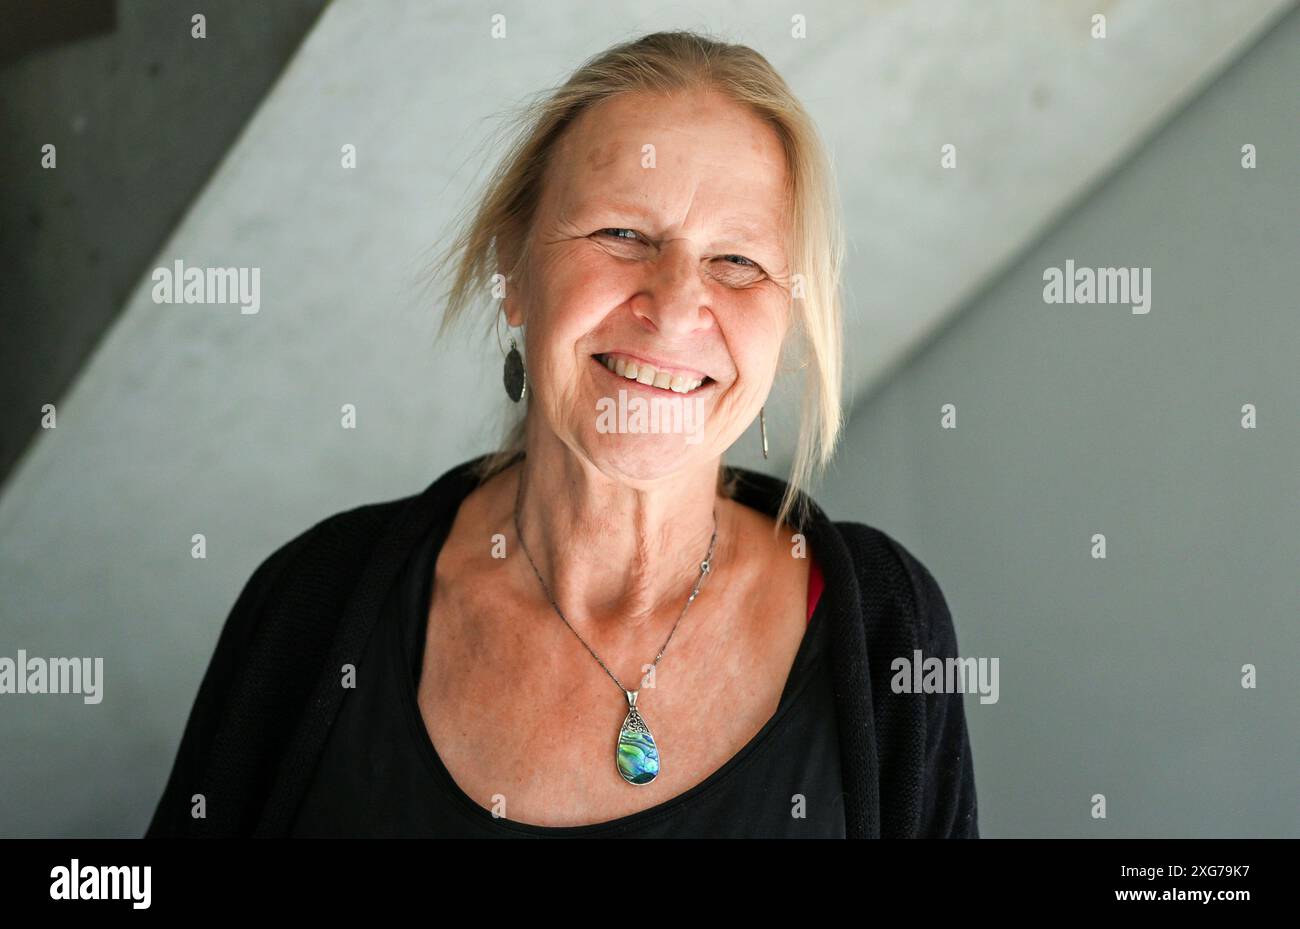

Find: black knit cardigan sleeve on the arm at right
[902,545,979,838]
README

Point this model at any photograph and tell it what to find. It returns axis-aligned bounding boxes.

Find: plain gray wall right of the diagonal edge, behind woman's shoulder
[820,14,1300,837]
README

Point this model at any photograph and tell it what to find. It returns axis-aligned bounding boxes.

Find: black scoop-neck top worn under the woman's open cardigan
[291,504,845,838]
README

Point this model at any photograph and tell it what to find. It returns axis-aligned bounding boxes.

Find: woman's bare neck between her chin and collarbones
[512,430,728,628]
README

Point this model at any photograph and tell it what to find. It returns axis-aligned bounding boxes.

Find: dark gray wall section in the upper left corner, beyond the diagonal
[0,0,325,483]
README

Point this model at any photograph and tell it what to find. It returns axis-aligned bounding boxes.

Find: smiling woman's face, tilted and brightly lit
[506,92,792,481]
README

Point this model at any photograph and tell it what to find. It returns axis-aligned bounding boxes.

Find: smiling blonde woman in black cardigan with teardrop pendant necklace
[148,32,978,837]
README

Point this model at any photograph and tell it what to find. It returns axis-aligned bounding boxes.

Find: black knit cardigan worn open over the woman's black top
[146,459,979,838]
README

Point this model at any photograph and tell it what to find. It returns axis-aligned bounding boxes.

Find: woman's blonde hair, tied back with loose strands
[434,31,845,530]
